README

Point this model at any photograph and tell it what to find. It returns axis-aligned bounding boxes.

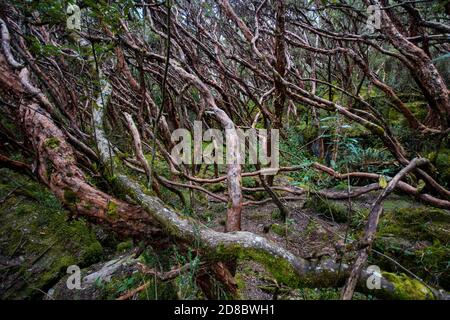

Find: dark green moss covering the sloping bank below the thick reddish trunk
[0,168,103,299]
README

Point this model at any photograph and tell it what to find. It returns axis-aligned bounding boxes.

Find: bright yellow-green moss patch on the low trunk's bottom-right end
[382,272,433,300]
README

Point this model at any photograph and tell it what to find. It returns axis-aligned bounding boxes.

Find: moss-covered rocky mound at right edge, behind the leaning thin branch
[372,207,450,290]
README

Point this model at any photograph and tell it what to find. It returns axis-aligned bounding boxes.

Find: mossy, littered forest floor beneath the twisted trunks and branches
[0,169,450,299]
